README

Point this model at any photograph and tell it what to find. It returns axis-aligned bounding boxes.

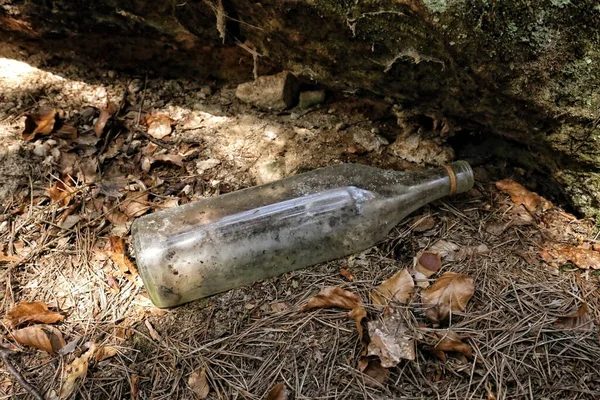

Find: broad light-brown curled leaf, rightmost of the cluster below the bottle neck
[421,272,475,322]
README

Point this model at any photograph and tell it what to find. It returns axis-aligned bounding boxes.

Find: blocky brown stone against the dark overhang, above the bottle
[235,71,298,111]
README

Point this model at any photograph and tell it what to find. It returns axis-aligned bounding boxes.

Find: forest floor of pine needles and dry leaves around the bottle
[0,47,600,400]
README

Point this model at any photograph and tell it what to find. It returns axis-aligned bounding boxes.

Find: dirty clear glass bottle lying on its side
[132,162,473,307]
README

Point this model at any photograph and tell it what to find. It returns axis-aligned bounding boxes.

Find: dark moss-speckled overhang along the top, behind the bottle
[0,0,600,215]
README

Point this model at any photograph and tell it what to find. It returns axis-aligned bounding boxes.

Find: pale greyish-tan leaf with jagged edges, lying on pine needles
[368,312,415,368]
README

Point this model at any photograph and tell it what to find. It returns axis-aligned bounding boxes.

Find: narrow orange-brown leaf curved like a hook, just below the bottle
[301,286,367,339]
